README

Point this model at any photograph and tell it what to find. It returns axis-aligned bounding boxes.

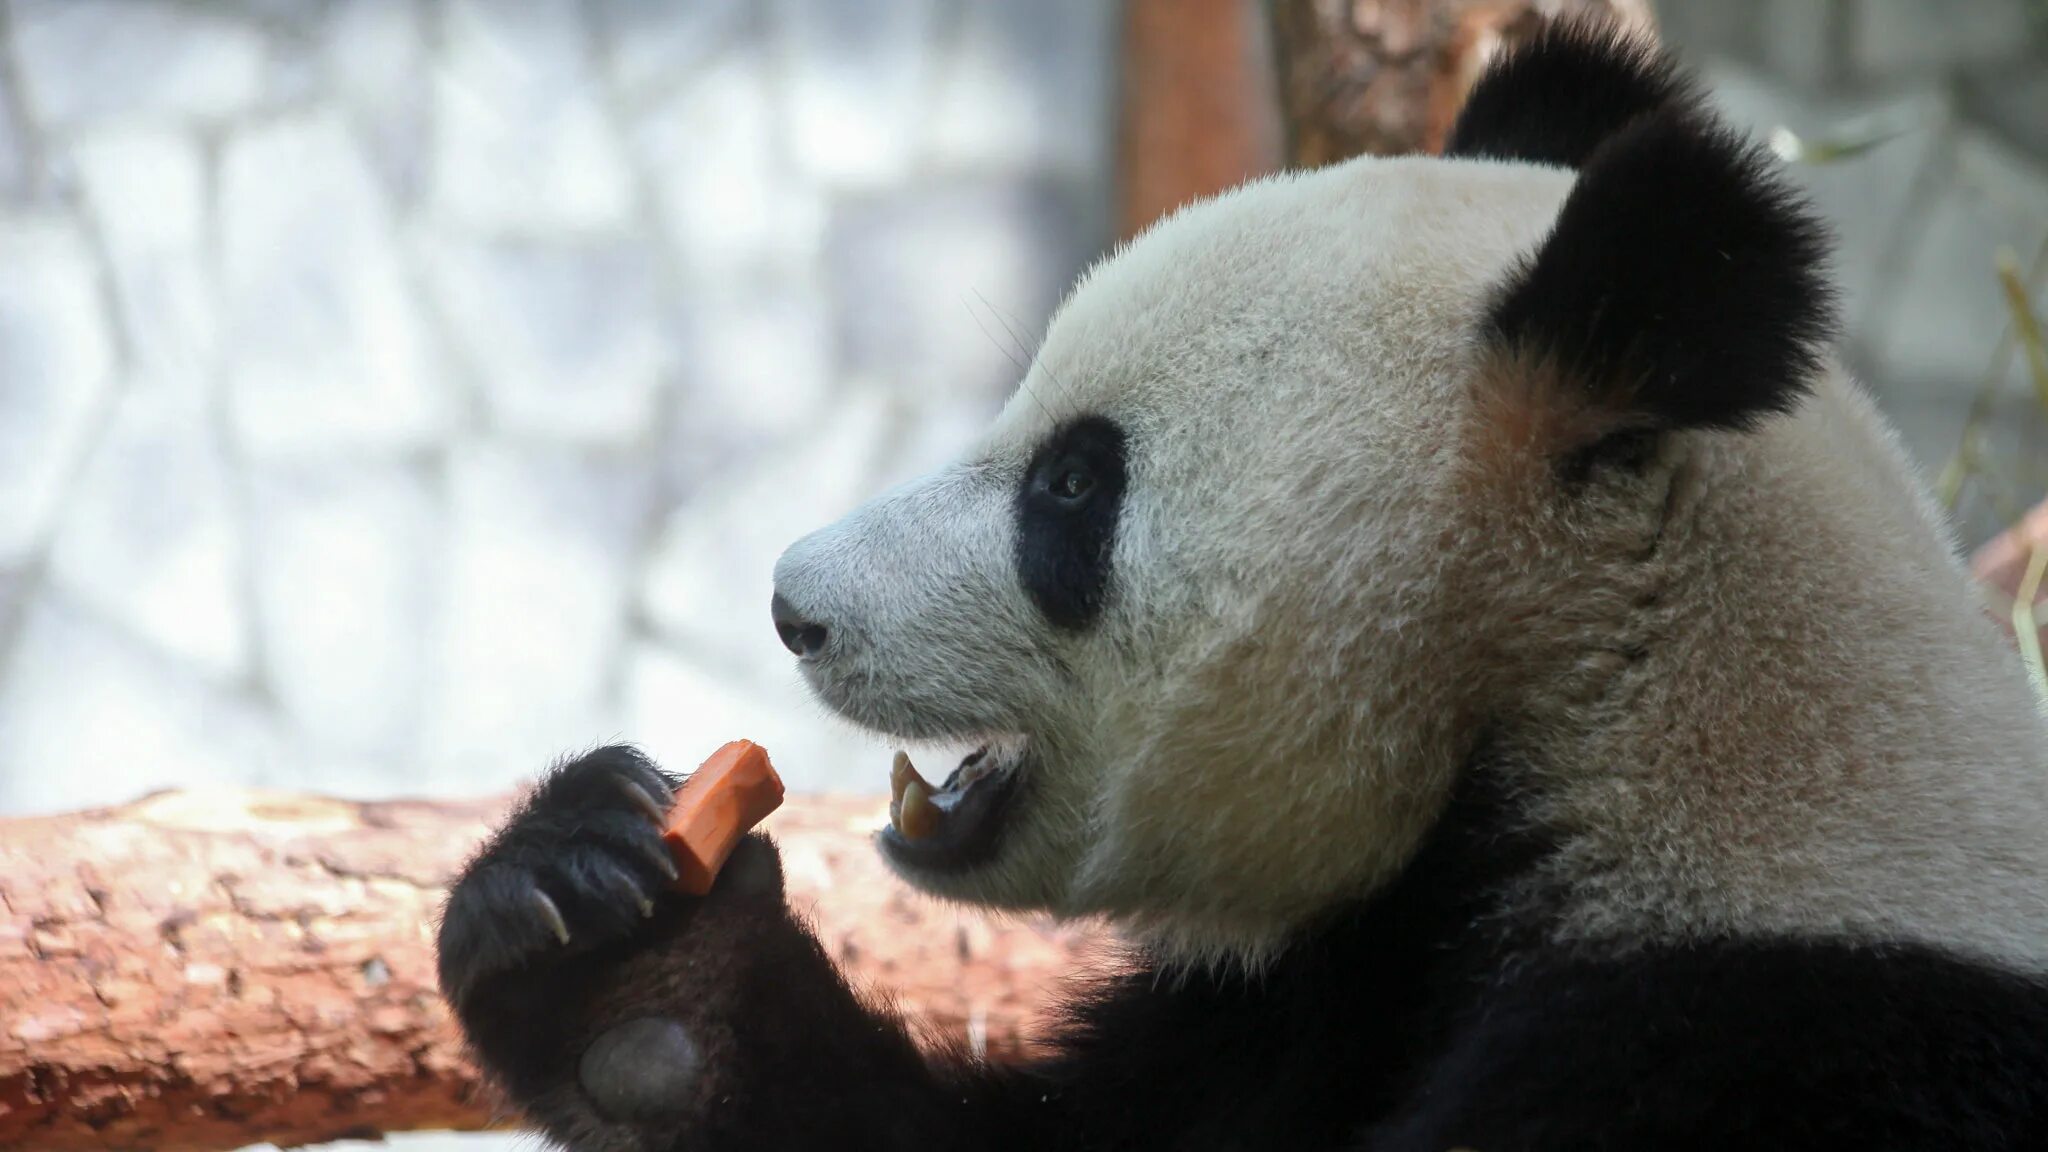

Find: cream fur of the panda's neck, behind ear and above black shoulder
[1497,373,2048,968]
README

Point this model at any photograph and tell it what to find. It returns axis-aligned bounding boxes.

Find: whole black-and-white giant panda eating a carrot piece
[440,27,2048,1152]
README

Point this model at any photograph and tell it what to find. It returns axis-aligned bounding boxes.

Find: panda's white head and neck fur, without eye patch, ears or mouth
[776,145,2048,965]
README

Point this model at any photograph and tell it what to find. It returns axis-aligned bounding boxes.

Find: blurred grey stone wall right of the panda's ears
[1657,0,2048,545]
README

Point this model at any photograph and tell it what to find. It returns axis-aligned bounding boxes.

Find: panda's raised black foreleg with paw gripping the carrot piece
[440,748,1059,1152]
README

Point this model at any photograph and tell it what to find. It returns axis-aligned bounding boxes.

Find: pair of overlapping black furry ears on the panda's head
[1448,27,1835,434]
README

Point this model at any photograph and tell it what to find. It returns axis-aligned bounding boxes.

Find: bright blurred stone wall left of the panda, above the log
[0,0,1114,814]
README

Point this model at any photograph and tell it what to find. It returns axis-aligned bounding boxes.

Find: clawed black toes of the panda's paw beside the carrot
[440,746,676,1006]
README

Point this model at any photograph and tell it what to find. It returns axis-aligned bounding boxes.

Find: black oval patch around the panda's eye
[1018,416,1126,631]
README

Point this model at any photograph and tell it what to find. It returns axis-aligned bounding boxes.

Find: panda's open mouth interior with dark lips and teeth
[881,736,1030,871]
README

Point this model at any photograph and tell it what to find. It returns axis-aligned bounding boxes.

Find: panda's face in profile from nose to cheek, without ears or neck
[776,158,1569,953]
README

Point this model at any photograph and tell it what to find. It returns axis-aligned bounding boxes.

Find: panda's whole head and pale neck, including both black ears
[774,22,2048,970]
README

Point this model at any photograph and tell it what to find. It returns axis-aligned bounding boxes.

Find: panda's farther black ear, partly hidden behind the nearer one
[1444,20,1702,168]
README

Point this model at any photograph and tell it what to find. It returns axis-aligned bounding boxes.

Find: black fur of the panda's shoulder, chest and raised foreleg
[442,754,2048,1152]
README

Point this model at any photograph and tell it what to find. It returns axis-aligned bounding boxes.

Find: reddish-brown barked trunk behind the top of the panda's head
[1266,0,1651,168]
